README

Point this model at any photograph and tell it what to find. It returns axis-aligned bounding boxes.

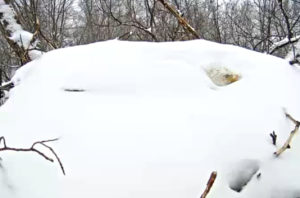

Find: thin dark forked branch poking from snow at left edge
[0,136,66,175]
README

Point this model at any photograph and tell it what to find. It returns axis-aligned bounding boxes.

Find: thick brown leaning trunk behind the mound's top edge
[158,0,200,39]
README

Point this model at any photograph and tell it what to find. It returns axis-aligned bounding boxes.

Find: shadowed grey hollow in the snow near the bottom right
[229,159,259,192]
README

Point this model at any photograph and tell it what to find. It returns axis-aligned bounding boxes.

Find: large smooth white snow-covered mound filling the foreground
[0,40,300,198]
